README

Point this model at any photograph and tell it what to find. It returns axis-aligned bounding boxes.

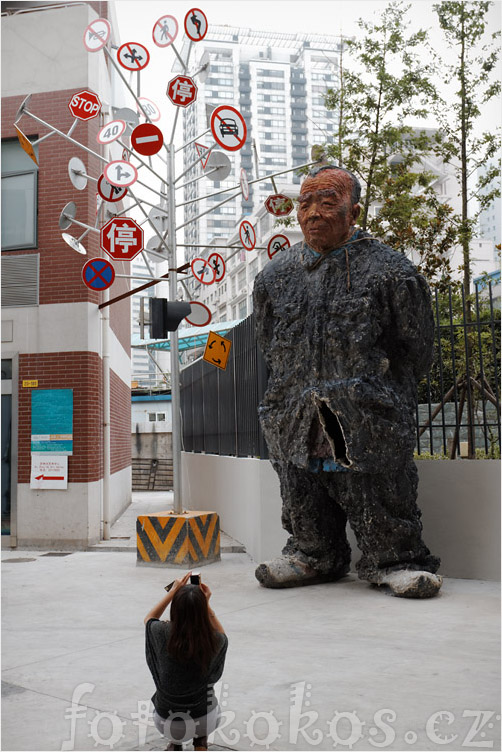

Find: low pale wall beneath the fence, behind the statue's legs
[182,452,500,580]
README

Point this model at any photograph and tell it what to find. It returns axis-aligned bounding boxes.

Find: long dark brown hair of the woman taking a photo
[167,585,217,670]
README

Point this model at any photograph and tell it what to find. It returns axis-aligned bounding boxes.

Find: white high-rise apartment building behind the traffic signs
[178,26,340,308]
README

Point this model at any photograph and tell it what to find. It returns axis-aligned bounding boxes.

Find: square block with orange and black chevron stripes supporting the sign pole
[136,512,220,569]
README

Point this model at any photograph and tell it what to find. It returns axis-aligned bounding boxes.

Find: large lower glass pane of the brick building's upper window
[2,172,37,250]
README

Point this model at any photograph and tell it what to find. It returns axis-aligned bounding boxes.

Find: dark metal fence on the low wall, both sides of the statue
[181,285,500,459]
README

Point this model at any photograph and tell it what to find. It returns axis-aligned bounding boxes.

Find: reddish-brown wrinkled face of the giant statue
[298,170,360,253]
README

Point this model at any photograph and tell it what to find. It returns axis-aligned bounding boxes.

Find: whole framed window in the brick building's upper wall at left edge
[2,140,38,251]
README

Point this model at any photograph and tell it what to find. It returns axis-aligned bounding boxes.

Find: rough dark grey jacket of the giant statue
[253,231,434,473]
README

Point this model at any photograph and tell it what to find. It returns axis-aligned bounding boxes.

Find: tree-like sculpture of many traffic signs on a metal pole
[15,6,322,524]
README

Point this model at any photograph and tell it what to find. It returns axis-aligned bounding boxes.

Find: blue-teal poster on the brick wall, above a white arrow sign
[31,389,73,454]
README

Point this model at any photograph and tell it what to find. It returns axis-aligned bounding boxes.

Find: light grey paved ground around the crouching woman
[2,496,500,750]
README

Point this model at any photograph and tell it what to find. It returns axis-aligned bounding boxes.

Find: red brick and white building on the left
[2,2,131,547]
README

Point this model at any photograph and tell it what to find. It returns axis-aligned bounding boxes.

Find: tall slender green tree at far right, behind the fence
[431,1,500,302]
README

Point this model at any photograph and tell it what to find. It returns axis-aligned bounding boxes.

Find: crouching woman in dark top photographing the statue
[145,572,228,750]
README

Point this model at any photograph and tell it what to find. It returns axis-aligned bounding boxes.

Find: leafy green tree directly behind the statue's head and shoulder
[326,2,455,284]
